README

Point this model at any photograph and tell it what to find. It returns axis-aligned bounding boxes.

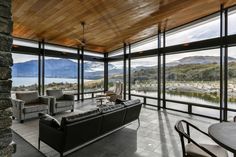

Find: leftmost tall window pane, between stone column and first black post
[12,53,38,96]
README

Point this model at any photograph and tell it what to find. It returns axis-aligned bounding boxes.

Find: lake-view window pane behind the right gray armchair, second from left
[45,57,78,94]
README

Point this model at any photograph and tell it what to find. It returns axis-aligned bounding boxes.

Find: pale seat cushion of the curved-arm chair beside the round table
[186,143,228,157]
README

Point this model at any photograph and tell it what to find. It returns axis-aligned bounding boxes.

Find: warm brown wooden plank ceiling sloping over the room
[13,0,236,52]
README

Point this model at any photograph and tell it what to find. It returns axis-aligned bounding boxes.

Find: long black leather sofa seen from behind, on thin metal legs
[38,100,142,156]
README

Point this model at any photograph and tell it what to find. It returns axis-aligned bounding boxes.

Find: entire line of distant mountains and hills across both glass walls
[12,56,236,80]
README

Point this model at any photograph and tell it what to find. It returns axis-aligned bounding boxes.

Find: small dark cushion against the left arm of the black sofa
[39,113,60,129]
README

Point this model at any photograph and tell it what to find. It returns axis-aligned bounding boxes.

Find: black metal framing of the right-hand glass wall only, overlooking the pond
[108,5,236,121]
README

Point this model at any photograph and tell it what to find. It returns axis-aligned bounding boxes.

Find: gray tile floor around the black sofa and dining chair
[12,100,232,157]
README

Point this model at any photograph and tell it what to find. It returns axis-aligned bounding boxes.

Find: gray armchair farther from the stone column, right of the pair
[46,90,74,115]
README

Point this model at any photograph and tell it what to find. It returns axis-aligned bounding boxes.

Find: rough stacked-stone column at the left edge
[0,0,15,157]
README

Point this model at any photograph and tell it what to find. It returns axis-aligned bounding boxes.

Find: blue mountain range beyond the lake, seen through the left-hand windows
[12,59,116,80]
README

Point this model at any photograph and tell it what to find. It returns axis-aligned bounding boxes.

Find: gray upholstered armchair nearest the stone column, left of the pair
[12,92,50,123]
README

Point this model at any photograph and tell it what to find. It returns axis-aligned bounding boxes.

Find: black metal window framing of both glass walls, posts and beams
[12,5,236,121]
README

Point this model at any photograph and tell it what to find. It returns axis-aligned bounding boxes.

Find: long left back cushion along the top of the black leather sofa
[61,109,101,127]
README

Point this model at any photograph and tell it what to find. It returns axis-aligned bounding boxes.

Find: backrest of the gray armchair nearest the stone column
[16,92,39,104]
